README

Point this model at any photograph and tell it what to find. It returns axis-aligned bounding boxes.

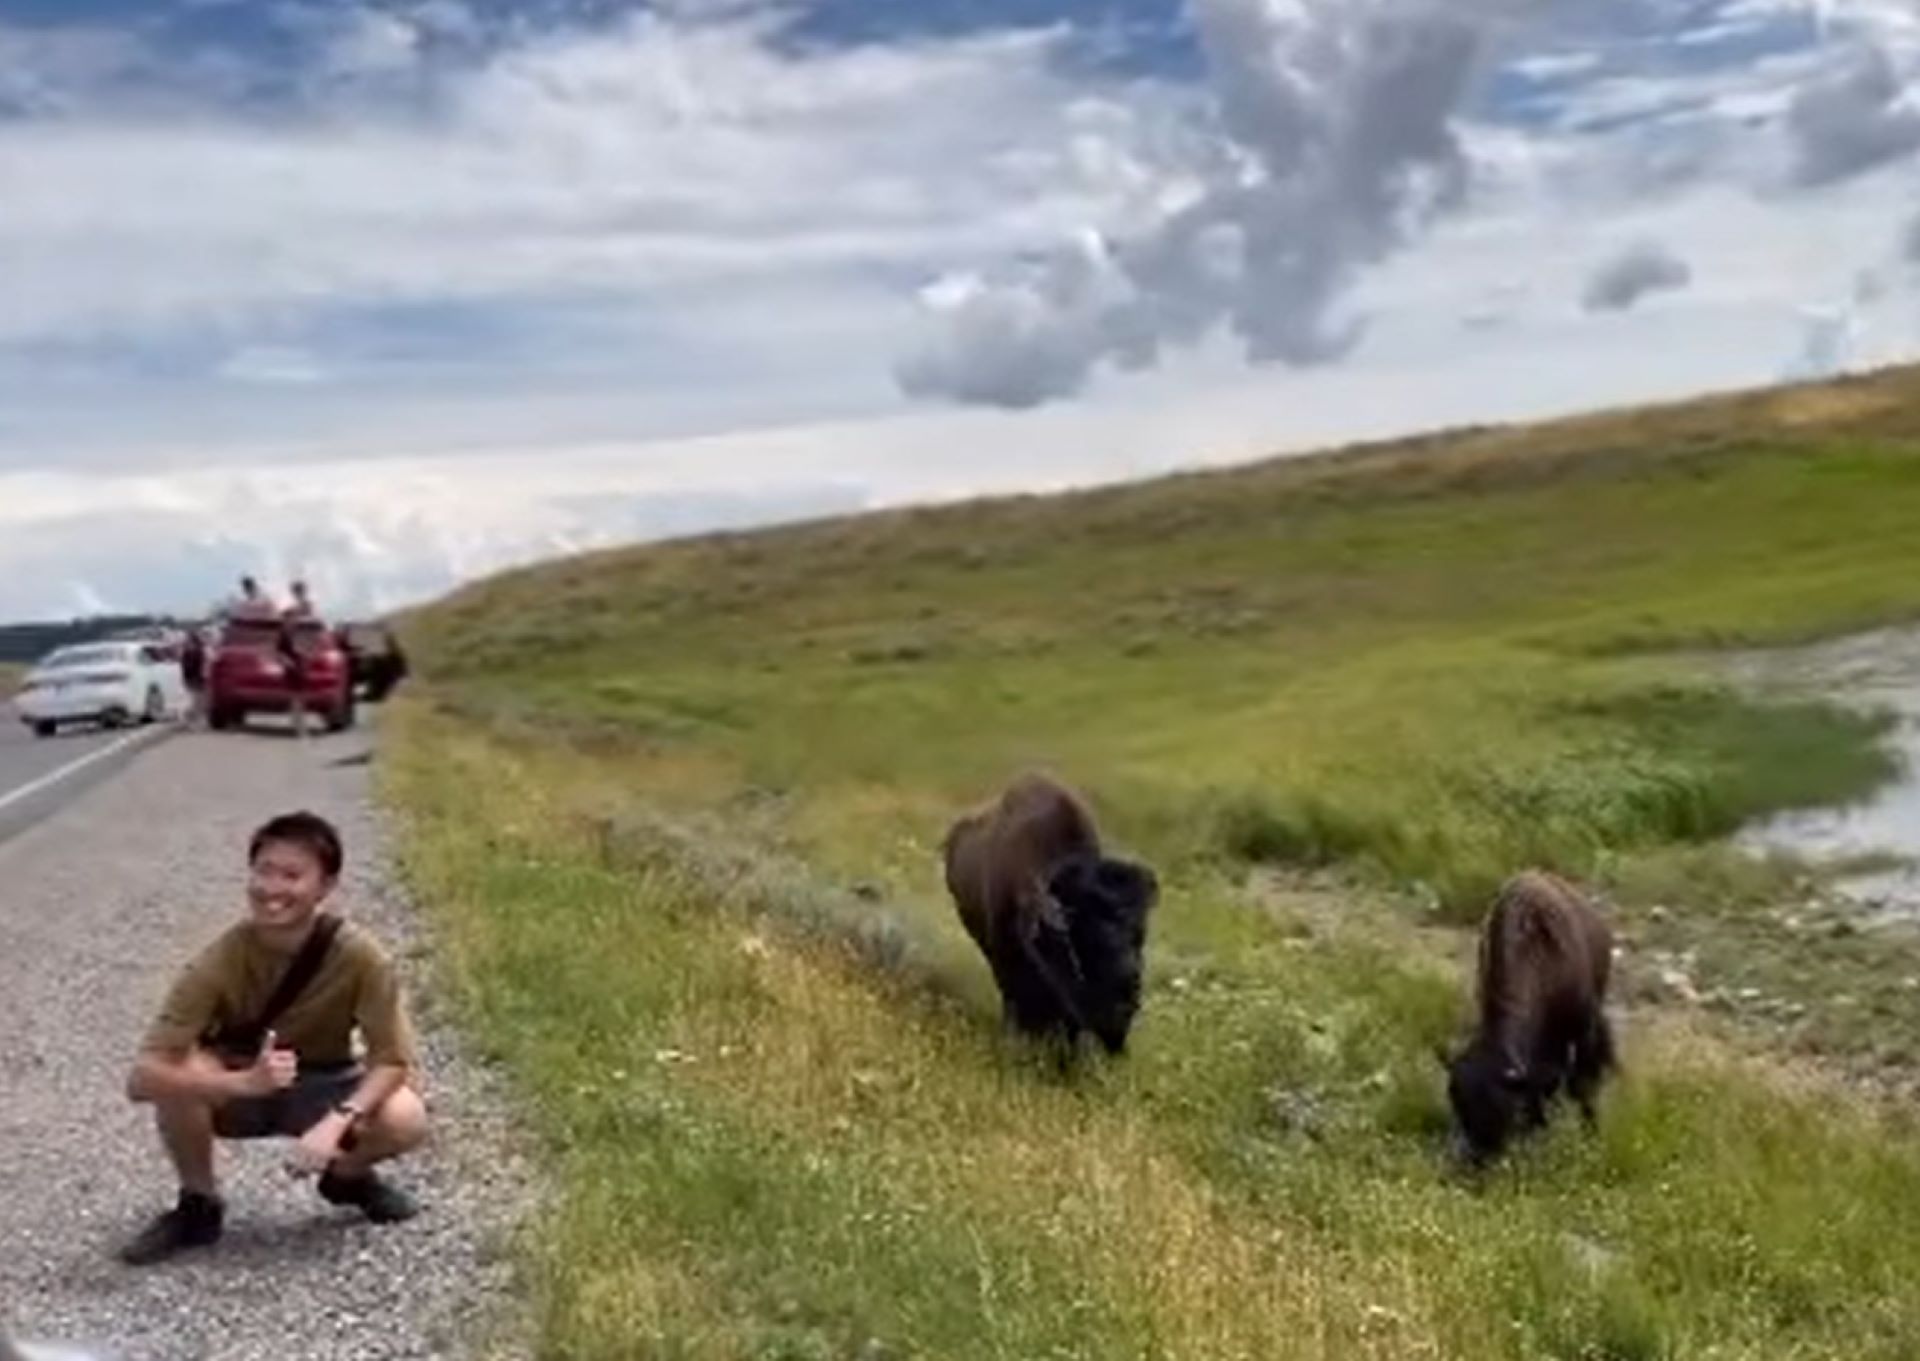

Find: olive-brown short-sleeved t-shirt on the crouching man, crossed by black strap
[142,921,419,1071]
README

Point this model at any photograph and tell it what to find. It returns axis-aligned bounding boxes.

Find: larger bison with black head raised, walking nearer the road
[943,774,1160,1054]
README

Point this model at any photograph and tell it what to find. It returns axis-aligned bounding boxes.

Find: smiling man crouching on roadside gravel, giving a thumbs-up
[121,812,426,1265]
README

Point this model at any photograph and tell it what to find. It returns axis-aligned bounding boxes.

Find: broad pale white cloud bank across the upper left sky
[0,10,1137,342]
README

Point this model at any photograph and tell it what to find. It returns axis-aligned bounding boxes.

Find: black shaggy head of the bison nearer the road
[1048,856,1160,1054]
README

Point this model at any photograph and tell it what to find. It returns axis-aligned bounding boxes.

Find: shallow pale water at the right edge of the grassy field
[1726,628,1920,921]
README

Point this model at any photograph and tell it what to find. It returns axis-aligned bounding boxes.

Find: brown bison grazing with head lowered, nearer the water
[1448,872,1617,1165]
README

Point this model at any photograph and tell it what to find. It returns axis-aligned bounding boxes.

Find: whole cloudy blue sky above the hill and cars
[0,0,1920,616]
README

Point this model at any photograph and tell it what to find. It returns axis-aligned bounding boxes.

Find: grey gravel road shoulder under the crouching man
[0,729,536,1361]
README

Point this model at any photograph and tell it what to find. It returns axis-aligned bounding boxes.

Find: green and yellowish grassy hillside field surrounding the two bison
[384,372,1920,1361]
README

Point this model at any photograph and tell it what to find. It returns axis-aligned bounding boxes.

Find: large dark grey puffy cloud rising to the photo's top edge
[899,0,1532,407]
